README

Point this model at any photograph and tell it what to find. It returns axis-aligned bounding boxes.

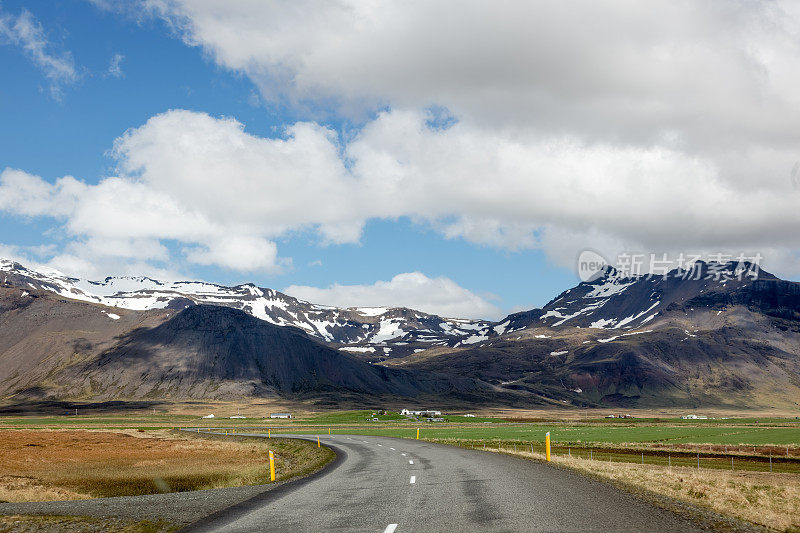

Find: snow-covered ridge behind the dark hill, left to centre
[0,259,491,360]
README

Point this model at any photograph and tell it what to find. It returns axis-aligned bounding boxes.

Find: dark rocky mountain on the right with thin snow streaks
[386,263,800,409]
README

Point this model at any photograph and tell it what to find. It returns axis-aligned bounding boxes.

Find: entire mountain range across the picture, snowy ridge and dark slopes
[0,262,800,409]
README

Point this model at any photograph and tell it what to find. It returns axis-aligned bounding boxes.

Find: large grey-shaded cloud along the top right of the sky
[143,0,800,150]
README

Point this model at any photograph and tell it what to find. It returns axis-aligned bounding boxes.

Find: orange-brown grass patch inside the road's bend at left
[0,430,333,502]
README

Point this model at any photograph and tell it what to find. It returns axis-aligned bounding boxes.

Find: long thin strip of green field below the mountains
[0,410,800,448]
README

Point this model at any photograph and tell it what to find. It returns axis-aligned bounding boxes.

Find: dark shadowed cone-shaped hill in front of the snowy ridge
[1,298,490,400]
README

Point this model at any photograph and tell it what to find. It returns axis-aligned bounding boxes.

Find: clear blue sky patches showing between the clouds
[0,0,576,312]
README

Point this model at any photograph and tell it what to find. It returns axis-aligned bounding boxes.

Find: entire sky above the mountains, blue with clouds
[0,0,800,319]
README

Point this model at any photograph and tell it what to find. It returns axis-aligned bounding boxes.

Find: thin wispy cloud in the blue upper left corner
[0,6,79,100]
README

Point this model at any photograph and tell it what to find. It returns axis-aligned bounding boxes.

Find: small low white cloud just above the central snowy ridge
[283,272,501,319]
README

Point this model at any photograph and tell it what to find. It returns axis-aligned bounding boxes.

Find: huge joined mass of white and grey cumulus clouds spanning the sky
[0,0,800,286]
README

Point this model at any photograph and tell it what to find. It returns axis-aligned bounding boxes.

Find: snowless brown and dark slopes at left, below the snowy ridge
[0,287,493,403]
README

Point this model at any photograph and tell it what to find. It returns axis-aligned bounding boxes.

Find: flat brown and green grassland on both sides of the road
[0,408,800,531]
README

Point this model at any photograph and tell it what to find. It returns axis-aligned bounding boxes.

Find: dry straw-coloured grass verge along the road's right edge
[494,446,800,531]
